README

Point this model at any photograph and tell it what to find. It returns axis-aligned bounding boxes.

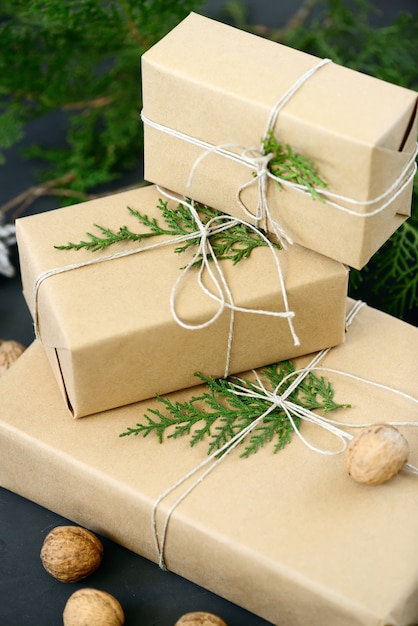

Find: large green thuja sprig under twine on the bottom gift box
[120,361,350,458]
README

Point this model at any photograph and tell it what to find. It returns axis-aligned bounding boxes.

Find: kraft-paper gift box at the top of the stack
[142,13,417,269]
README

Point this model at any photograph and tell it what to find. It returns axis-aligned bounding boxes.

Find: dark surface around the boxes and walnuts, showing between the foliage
[0,0,418,626]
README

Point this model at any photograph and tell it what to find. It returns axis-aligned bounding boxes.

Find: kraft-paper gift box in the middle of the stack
[17,186,348,417]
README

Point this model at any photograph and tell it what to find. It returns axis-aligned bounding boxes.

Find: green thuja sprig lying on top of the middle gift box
[54,199,280,266]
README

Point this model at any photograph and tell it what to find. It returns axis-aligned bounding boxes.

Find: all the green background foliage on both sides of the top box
[0,0,418,318]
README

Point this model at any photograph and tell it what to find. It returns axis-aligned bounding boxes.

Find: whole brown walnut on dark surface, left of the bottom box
[41,526,103,583]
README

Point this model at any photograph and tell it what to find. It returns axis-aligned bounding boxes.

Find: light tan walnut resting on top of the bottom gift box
[345,424,409,485]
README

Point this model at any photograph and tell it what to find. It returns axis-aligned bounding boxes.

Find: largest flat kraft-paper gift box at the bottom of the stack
[0,301,418,626]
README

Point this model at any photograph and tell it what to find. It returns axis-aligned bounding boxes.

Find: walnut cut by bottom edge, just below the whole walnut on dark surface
[63,587,125,626]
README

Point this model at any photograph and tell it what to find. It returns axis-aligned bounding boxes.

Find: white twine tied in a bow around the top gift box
[141,54,418,235]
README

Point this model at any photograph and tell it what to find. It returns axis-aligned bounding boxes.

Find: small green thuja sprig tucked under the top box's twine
[262,130,327,202]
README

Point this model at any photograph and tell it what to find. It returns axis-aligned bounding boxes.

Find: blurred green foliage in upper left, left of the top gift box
[0,0,200,197]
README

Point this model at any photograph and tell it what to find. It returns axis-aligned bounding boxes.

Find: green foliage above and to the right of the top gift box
[228,0,418,323]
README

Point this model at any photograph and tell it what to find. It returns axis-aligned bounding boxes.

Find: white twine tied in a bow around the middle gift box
[32,187,300,377]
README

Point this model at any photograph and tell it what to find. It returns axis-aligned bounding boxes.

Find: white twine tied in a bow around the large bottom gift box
[151,301,418,570]
